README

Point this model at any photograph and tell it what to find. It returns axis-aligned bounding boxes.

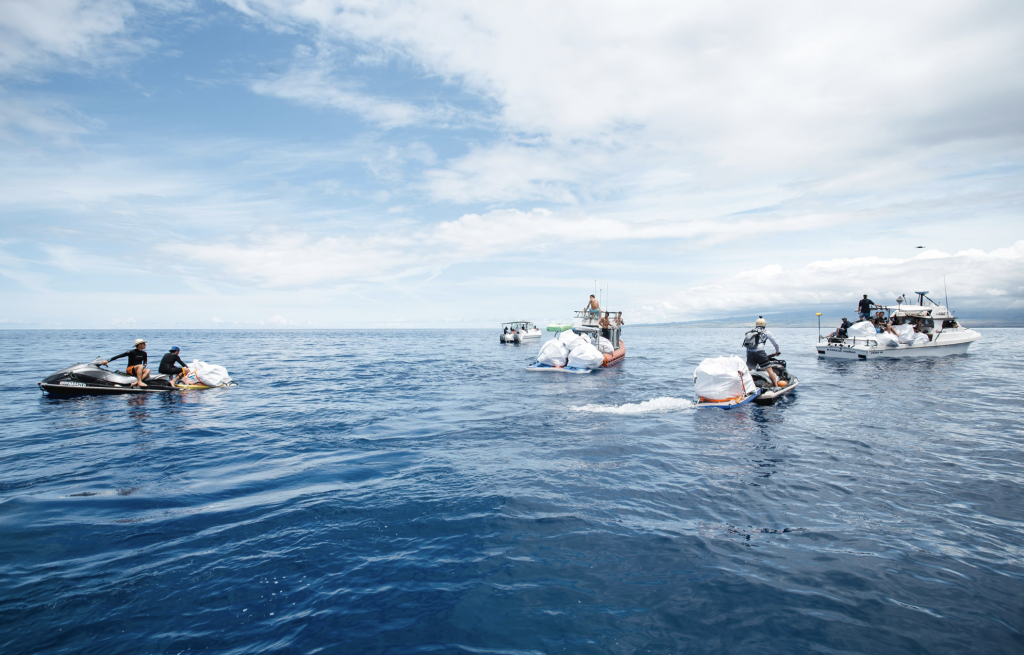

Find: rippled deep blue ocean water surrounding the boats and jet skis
[0,326,1024,655]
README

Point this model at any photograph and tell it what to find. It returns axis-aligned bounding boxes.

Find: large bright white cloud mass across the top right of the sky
[231,0,1024,145]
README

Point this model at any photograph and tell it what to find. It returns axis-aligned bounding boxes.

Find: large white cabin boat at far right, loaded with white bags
[817,291,981,359]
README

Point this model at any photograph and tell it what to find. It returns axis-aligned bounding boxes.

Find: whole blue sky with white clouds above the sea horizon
[0,0,1024,330]
